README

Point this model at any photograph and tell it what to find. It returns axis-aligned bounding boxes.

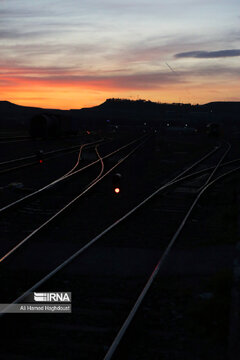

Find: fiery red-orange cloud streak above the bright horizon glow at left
[0,66,185,89]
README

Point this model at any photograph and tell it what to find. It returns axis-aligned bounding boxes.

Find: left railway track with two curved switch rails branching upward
[0,136,150,268]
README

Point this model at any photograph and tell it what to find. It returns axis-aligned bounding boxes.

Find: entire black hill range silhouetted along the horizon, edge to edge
[0,99,240,128]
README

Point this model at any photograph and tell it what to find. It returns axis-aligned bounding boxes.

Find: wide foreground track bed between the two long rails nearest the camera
[0,139,240,359]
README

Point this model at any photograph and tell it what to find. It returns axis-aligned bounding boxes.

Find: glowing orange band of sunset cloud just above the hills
[0,66,240,109]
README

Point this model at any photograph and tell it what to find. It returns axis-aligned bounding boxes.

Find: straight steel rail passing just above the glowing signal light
[0,138,148,263]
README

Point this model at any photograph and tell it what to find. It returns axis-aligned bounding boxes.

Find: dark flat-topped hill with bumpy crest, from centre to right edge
[71,99,240,127]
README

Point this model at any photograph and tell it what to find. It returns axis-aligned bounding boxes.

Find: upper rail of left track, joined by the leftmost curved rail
[0,135,146,214]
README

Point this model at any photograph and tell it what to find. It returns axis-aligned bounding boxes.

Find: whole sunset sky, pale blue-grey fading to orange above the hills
[0,0,240,109]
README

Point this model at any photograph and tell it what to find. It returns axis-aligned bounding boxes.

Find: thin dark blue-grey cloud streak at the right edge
[175,49,240,59]
